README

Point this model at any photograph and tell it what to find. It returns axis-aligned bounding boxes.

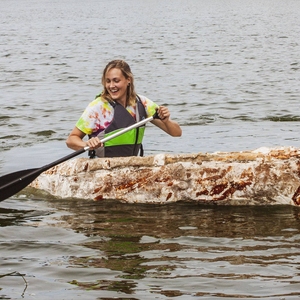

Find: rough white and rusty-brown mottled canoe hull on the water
[31,148,300,205]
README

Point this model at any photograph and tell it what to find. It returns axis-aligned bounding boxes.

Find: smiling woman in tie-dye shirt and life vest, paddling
[66,60,182,157]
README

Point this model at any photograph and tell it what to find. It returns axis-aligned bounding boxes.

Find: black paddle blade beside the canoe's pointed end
[0,169,43,201]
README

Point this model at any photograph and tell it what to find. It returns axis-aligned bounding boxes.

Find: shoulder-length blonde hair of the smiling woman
[102,59,137,105]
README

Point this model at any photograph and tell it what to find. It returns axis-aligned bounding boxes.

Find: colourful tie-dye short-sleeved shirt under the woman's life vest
[76,95,158,135]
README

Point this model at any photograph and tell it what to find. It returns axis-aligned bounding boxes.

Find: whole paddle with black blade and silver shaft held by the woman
[0,113,158,201]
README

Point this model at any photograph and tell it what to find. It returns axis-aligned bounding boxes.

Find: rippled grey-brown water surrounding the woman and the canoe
[0,0,300,299]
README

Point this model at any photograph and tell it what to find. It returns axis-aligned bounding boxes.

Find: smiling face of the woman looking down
[105,68,130,106]
